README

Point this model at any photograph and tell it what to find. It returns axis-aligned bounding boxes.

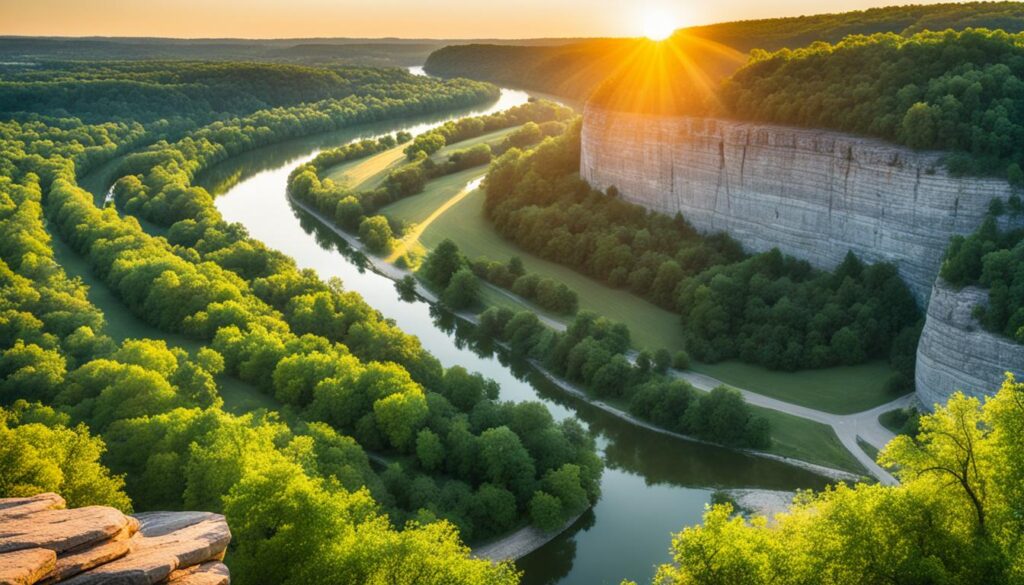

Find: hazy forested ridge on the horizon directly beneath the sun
[426,2,1024,109]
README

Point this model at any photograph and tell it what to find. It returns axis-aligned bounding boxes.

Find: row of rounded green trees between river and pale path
[418,240,771,450]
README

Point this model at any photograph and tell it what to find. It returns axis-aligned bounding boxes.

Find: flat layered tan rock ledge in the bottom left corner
[0,494,231,585]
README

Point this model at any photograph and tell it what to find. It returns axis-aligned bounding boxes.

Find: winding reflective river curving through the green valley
[82,72,826,585]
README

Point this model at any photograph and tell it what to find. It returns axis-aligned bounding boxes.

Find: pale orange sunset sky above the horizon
[0,0,970,38]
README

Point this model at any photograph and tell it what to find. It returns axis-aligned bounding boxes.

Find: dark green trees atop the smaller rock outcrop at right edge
[940,200,1024,343]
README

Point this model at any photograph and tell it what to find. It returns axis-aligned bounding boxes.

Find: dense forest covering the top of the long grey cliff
[720,30,1024,184]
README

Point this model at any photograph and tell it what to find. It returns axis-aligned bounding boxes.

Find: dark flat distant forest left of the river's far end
[0,61,497,131]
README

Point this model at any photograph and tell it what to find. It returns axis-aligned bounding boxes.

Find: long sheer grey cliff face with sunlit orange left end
[580,107,1010,306]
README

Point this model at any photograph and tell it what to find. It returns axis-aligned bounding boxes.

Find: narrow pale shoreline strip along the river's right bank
[288,195,881,482]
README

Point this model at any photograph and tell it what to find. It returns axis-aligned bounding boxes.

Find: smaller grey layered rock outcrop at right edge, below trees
[915,279,1024,409]
